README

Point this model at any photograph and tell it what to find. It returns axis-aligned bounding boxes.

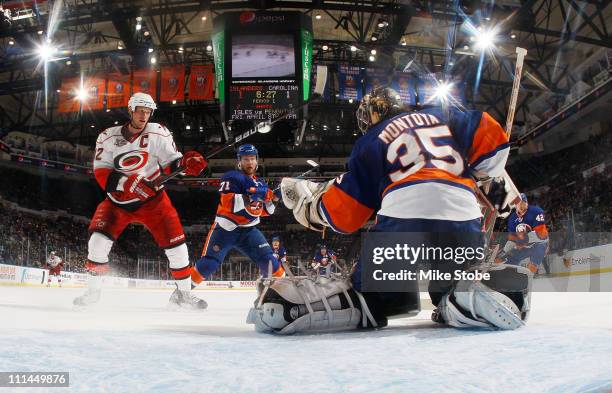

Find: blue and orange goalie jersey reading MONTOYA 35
[319,108,509,232]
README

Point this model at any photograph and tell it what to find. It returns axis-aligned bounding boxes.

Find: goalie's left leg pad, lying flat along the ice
[247,277,377,334]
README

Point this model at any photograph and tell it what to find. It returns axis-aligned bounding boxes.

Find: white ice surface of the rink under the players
[0,286,612,393]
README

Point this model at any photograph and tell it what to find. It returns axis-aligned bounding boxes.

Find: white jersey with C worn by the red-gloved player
[93,123,182,209]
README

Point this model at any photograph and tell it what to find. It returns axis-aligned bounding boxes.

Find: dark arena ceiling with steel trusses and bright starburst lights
[0,0,612,156]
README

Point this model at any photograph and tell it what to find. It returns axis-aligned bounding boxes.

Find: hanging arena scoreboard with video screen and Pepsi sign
[213,11,312,123]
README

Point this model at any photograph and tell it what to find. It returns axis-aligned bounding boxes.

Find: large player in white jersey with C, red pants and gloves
[74,93,207,309]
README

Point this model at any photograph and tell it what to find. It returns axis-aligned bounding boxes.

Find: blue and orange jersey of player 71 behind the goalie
[215,171,275,231]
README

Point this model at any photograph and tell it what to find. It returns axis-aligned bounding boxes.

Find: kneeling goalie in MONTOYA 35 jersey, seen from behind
[247,88,532,334]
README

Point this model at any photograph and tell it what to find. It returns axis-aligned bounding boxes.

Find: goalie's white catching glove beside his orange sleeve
[281,177,334,232]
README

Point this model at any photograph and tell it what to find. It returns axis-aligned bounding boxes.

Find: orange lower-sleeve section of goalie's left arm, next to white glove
[322,184,374,233]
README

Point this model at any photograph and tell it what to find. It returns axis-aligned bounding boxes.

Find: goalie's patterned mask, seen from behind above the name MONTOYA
[357,87,403,134]
